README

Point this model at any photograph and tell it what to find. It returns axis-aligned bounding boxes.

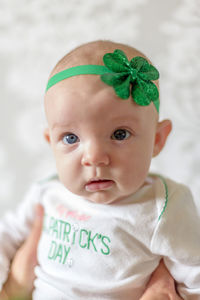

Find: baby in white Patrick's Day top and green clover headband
[0,41,200,300]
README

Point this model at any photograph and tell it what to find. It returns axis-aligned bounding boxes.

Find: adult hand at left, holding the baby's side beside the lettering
[0,204,44,300]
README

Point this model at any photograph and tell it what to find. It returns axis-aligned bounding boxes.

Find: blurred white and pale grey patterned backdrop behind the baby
[0,0,200,215]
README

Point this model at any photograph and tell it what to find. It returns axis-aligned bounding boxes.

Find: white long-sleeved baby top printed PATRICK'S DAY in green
[0,175,200,300]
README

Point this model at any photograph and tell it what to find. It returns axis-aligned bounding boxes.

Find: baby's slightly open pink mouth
[85,179,114,192]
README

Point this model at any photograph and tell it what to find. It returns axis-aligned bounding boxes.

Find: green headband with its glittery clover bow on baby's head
[46,49,160,112]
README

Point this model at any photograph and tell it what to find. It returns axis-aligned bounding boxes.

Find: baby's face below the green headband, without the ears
[45,75,157,204]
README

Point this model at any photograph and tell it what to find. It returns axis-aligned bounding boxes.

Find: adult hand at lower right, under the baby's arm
[140,261,182,300]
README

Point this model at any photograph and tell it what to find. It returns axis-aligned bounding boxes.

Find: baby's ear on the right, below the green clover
[153,120,172,157]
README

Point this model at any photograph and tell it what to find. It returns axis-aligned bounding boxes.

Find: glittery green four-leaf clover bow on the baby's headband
[101,49,159,111]
